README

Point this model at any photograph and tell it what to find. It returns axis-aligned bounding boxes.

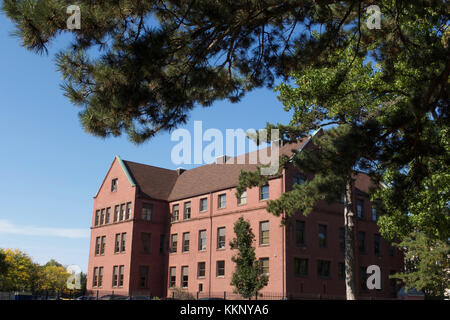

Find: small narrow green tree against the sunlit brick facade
[230,217,269,298]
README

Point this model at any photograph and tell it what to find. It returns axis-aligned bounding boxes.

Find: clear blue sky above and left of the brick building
[0,13,289,271]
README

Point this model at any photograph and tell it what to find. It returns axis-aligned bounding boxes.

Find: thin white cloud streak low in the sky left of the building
[0,220,89,239]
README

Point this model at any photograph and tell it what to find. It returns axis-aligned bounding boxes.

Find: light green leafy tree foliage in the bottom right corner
[391,233,450,297]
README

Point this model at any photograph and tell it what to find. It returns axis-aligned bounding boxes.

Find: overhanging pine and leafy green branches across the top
[2,0,450,143]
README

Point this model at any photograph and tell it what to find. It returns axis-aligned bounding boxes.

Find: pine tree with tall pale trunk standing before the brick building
[236,125,368,300]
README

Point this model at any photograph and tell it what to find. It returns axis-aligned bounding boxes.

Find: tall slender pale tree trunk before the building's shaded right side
[344,177,356,300]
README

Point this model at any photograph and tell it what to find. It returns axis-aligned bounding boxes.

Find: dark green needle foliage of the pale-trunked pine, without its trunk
[236,125,362,223]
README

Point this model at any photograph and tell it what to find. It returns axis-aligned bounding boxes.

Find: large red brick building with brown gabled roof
[87,139,403,298]
